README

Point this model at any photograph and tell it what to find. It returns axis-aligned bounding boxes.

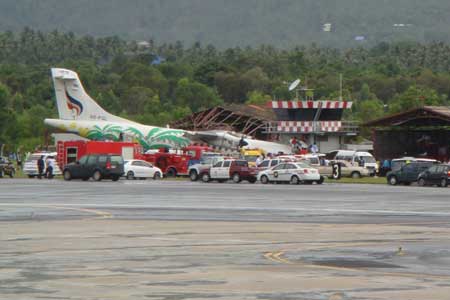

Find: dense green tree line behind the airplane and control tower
[0,28,450,149]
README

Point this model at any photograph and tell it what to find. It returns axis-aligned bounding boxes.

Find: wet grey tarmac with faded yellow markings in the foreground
[0,178,450,300]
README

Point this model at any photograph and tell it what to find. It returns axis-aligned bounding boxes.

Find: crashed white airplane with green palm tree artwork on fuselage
[44,68,291,153]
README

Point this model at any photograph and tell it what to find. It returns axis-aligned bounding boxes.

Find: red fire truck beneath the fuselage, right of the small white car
[140,146,213,177]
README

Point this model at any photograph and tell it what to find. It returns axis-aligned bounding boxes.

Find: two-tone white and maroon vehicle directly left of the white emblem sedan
[201,159,258,183]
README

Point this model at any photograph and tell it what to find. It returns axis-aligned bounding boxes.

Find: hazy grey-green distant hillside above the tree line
[0,0,450,48]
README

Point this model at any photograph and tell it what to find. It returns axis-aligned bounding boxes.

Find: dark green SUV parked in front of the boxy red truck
[63,154,124,181]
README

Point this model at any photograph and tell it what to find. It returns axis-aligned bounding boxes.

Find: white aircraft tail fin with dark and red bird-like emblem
[52,68,116,121]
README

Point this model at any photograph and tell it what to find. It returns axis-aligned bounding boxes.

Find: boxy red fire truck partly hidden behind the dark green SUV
[56,141,142,170]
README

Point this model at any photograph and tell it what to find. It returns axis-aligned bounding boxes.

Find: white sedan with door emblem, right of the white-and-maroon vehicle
[258,162,323,184]
